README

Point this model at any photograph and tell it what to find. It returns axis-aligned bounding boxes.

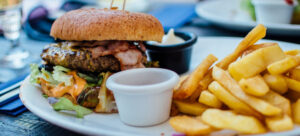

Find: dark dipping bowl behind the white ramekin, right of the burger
[145,31,197,74]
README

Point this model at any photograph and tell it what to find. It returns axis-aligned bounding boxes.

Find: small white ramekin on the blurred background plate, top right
[252,0,298,24]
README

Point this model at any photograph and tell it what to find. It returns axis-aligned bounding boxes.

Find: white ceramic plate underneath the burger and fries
[20,37,300,136]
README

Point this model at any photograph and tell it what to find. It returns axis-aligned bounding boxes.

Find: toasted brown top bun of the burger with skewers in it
[50,9,164,42]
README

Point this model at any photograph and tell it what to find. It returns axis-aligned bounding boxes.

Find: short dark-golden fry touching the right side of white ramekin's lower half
[173,100,208,116]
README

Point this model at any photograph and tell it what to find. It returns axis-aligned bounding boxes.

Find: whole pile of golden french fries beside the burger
[169,24,300,135]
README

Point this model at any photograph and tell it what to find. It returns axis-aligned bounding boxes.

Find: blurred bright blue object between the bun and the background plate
[149,3,197,32]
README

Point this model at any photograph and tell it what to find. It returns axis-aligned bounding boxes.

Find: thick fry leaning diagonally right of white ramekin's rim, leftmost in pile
[173,54,217,100]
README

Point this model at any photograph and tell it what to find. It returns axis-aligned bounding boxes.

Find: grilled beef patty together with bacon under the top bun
[41,41,146,72]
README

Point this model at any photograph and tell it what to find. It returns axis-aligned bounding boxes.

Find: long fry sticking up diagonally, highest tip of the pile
[199,24,267,90]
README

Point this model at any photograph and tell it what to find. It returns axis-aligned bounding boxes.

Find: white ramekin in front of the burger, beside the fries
[106,68,179,126]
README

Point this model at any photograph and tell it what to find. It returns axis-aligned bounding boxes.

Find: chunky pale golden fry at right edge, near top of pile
[267,57,299,75]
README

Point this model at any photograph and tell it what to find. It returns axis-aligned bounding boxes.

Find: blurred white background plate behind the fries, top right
[196,0,300,36]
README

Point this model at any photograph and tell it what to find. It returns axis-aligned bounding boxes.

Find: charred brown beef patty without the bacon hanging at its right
[41,41,144,72]
